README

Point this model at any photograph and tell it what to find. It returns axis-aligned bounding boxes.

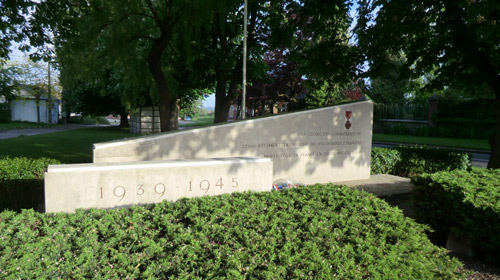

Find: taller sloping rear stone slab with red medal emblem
[93,101,373,184]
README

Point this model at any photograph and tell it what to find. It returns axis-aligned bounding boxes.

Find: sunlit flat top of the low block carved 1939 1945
[47,157,272,173]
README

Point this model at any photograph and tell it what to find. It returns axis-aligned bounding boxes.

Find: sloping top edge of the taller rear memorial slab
[93,100,373,150]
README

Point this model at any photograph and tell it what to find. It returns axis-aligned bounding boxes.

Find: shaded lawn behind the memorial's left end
[0,127,138,163]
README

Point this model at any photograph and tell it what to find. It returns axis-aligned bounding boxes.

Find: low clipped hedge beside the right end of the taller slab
[371,146,470,177]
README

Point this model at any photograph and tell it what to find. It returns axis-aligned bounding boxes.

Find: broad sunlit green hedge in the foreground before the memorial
[0,185,461,279]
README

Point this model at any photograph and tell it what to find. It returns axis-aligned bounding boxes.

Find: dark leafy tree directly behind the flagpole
[199,0,268,123]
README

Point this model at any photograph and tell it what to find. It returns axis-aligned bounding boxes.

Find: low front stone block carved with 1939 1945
[45,158,273,212]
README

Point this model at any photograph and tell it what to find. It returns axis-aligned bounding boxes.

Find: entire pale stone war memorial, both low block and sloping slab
[45,101,373,212]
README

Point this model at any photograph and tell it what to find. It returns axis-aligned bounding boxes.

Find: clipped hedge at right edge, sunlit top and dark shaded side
[413,168,500,264]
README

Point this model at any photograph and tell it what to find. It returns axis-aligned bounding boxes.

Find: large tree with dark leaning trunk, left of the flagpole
[34,0,238,131]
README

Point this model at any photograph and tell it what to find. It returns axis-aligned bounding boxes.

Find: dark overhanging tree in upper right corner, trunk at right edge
[357,0,500,168]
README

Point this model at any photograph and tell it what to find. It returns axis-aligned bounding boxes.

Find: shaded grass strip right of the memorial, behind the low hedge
[373,133,490,151]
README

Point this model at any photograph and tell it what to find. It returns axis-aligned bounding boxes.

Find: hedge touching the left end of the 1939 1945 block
[0,157,61,211]
